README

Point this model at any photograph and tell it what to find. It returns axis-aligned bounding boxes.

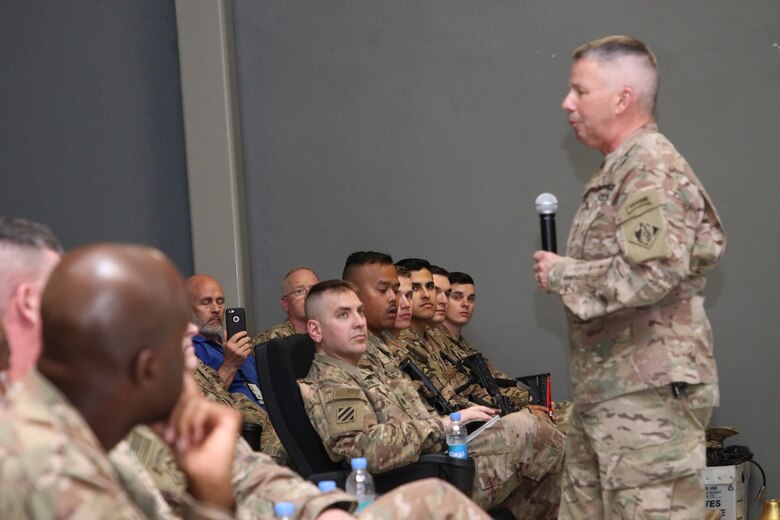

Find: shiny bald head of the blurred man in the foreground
[38,244,189,449]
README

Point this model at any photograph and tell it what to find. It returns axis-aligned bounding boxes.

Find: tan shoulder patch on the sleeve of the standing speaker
[618,190,670,264]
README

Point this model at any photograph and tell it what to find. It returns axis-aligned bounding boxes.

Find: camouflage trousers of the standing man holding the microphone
[558,385,717,520]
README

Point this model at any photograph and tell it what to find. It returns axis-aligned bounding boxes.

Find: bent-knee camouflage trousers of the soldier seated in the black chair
[469,409,565,519]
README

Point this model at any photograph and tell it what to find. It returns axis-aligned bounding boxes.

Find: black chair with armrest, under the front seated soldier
[255,334,474,494]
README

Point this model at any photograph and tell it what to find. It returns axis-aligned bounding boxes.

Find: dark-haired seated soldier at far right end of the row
[428,272,571,431]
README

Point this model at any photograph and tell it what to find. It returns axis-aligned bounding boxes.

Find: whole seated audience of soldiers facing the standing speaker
[0,219,564,519]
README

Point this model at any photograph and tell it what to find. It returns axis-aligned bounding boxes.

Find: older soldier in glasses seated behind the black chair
[252,267,319,347]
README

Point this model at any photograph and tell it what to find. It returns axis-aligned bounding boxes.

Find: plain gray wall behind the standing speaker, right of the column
[234,0,780,516]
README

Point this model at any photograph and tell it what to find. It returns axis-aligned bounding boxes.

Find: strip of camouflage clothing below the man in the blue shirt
[193,360,294,469]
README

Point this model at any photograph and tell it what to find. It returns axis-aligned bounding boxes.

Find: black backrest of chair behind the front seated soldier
[255,334,344,478]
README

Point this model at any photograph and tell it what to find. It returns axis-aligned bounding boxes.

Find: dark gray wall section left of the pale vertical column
[0,0,193,273]
